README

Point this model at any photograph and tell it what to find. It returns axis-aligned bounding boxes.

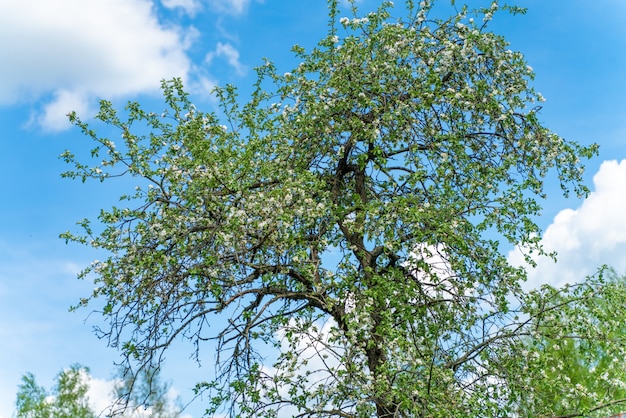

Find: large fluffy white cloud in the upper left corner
[0,0,191,130]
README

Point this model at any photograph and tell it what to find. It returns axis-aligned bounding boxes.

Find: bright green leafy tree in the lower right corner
[508,270,626,417]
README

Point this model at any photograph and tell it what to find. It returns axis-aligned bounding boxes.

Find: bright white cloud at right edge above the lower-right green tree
[509,160,626,288]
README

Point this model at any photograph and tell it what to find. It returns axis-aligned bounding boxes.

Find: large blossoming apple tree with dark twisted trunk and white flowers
[58,0,616,417]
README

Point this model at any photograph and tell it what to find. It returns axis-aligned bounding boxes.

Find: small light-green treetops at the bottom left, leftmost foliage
[16,365,96,418]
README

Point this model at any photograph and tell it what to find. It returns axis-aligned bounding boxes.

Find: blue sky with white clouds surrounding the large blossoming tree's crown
[0,0,626,418]
